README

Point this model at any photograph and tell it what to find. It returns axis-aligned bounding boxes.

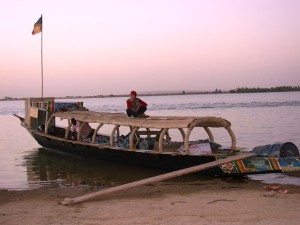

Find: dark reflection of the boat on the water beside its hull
[24,148,162,188]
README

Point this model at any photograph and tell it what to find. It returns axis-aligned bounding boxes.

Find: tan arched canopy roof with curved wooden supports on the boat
[45,110,236,153]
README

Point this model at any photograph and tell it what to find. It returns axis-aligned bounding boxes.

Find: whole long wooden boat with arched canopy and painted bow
[21,98,300,176]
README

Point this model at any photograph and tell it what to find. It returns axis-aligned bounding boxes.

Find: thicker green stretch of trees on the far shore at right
[230,85,300,93]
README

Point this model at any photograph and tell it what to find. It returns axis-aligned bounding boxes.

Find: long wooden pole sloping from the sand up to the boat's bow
[60,153,256,205]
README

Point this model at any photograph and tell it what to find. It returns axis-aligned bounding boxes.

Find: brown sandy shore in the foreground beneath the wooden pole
[0,179,300,225]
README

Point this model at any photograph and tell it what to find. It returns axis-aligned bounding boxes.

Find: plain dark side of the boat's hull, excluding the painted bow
[33,132,223,175]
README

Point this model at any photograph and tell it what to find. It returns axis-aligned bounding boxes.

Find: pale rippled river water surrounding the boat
[0,92,300,190]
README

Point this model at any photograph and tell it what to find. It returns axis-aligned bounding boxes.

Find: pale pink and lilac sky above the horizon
[0,0,300,98]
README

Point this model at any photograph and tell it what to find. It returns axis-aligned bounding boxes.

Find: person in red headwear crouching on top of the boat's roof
[126,91,147,117]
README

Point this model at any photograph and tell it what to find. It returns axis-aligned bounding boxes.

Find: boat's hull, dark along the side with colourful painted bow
[25,127,300,177]
